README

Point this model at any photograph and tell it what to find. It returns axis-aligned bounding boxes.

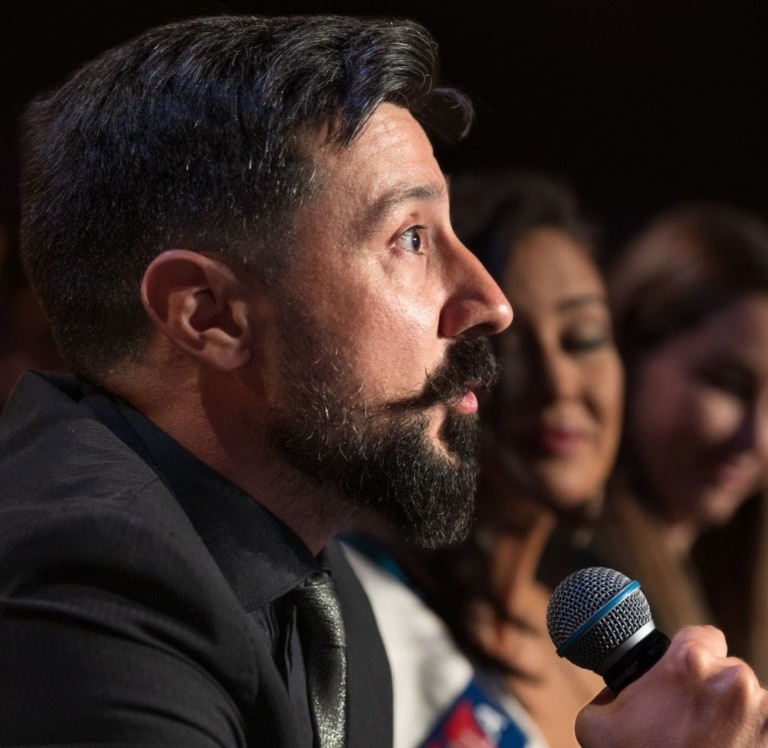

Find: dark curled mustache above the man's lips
[397,338,501,408]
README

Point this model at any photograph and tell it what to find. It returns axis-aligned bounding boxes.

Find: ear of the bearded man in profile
[141,249,251,371]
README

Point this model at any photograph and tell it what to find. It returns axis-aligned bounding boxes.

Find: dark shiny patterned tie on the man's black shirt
[291,571,347,748]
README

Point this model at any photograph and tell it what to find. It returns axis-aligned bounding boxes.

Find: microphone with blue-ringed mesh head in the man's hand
[547,566,669,693]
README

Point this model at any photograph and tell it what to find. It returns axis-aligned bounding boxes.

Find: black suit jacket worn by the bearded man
[0,375,392,748]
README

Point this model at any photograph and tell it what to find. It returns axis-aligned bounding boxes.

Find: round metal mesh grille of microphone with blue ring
[547,566,653,672]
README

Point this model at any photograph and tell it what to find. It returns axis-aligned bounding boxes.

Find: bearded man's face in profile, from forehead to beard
[262,105,511,545]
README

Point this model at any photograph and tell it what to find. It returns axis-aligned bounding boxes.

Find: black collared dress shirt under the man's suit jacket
[82,386,320,748]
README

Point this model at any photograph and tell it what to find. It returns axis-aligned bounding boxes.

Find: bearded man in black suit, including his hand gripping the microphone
[0,10,768,748]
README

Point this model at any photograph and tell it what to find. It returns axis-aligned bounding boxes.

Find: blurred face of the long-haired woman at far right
[627,293,768,529]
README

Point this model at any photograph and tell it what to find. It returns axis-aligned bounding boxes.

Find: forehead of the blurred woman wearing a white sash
[504,227,605,306]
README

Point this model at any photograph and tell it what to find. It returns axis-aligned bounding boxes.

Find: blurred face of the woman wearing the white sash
[488,228,623,512]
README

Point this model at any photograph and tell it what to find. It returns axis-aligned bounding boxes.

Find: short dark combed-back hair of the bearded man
[21,15,472,381]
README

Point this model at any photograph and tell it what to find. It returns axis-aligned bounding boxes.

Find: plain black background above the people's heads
[0,0,768,250]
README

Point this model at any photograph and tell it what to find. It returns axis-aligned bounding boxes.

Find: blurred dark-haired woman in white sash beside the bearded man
[342,174,622,748]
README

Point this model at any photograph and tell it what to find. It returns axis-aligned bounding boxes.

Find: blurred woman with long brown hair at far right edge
[568,204,768,682]
